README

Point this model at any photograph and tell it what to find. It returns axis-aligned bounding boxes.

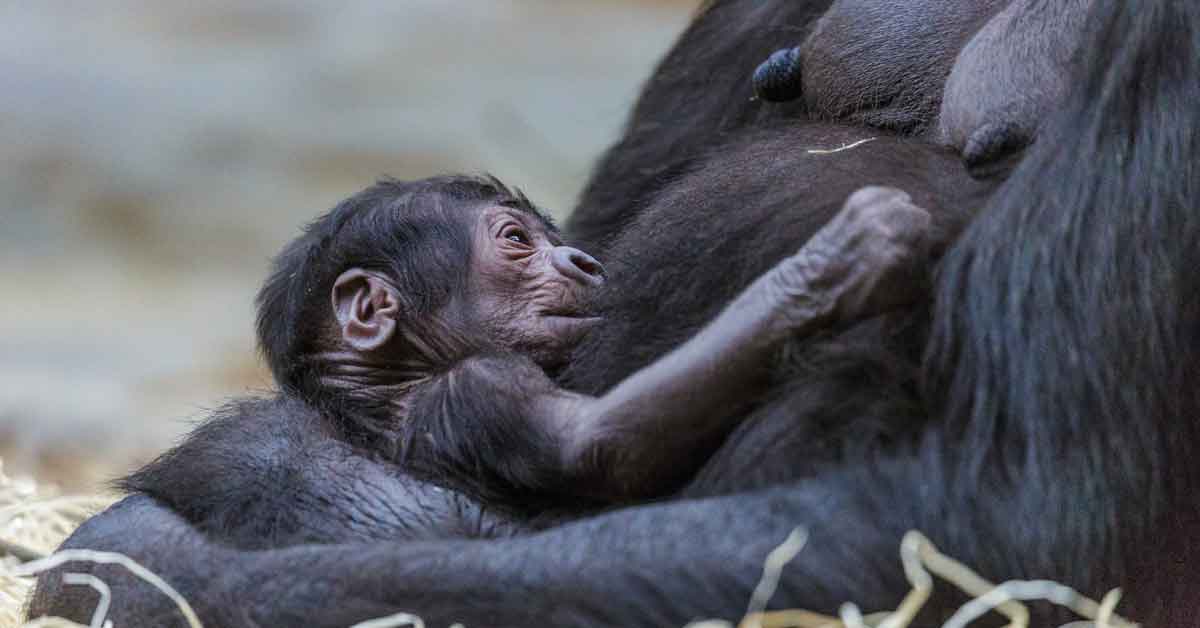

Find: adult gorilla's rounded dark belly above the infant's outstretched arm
[562,121,994,394]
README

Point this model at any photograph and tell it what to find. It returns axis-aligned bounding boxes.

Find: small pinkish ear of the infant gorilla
[332,268,400,352]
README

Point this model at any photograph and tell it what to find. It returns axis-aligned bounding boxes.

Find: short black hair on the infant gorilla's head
[257,177,548,400]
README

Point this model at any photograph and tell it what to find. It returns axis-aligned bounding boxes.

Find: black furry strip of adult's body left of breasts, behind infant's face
[566,0,832,251]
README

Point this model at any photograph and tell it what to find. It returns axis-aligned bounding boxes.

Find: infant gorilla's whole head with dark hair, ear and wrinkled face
[257,177,601,399]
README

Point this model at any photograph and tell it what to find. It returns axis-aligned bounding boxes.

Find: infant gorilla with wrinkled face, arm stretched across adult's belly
[260,178,929,501]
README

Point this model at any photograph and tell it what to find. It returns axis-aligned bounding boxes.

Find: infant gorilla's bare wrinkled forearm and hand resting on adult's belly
[491,187,930,498]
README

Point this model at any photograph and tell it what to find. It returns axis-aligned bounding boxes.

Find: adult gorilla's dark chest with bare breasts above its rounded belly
[569,0,1092,251]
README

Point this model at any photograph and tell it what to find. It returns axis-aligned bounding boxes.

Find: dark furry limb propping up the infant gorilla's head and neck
[120,395,516,549]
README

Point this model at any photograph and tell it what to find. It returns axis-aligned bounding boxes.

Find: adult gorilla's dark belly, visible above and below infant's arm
[562,121,992,494]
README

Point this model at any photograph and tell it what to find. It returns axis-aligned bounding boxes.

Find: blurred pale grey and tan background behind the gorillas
[0,0,700,491]
